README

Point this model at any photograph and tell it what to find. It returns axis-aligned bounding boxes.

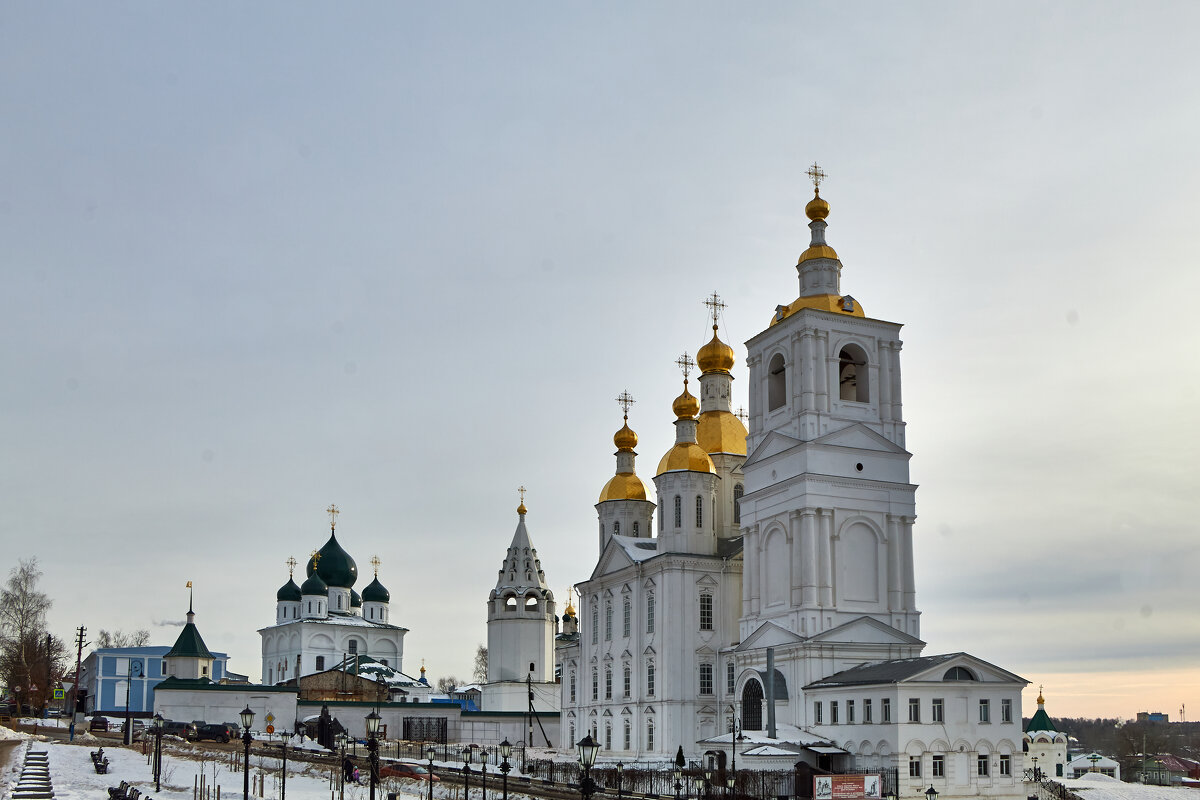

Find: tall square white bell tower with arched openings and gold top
[742,164,919,637]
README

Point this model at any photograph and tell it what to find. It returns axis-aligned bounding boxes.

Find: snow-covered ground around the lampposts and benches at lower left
[0,727,540,800]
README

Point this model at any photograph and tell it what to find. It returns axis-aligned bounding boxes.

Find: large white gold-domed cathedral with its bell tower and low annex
[544,168,1027,798]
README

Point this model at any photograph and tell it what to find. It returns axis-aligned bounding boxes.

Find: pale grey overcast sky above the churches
[0,2,1200,720]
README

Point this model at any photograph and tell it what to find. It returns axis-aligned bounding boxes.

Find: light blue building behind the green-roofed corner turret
[80,646,230,716]
